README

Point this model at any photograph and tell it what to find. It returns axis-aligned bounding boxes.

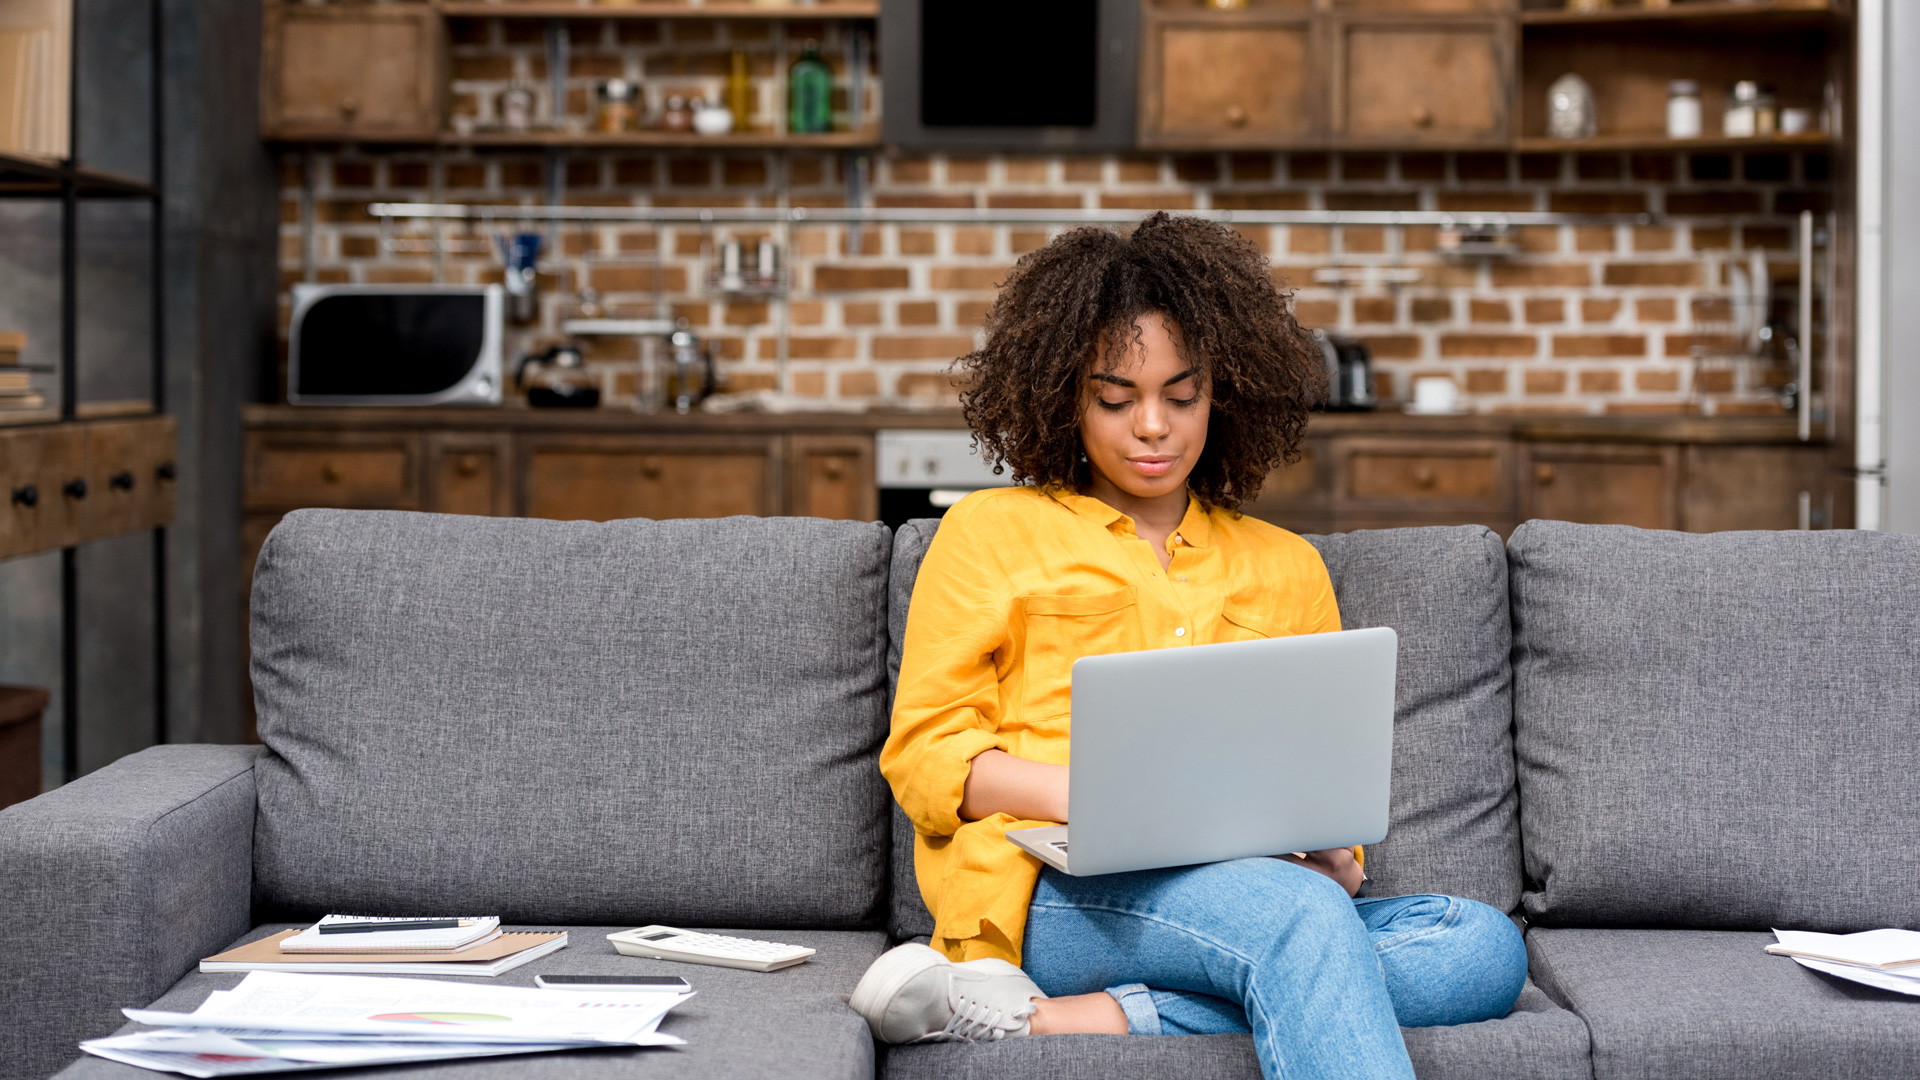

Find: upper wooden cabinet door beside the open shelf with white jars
[1331,15,1513,146]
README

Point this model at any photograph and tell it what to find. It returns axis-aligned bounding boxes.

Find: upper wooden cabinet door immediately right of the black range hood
[1140,15,1327,146]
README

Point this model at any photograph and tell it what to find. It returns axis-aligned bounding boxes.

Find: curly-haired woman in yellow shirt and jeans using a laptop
[852,213,1526,1078]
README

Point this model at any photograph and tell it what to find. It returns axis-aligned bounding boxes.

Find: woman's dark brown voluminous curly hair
[954,213,1325,509]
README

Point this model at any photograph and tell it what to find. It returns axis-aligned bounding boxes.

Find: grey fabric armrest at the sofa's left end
[0,746,259,1080]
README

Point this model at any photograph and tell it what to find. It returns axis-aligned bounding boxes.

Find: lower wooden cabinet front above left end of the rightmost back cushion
[1521,442,1680,528]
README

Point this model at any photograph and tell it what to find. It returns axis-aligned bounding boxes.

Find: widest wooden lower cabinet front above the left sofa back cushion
[522,436,781,521]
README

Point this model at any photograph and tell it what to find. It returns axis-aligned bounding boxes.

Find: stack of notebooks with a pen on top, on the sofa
[200,915,566,976]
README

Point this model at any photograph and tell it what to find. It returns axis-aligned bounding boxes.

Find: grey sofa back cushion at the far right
[1507,521,1920,930]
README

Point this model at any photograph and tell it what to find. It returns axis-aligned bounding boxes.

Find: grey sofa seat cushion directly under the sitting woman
[885,982,1592,1080]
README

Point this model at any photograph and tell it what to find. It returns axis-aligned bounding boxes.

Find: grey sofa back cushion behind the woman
[889,521,1521,926]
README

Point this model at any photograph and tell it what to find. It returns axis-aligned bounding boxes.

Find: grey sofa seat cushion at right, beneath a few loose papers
[1526,928,1920,1080]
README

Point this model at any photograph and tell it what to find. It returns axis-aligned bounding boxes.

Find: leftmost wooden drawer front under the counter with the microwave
[246,436,420,509]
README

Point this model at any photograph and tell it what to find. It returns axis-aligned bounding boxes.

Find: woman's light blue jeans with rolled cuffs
[1023,859,1526,1080]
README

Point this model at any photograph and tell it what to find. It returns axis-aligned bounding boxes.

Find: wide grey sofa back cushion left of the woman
[253,511,891,928]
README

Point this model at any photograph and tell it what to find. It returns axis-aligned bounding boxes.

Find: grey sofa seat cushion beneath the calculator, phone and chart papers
[60,924,887,1080]
